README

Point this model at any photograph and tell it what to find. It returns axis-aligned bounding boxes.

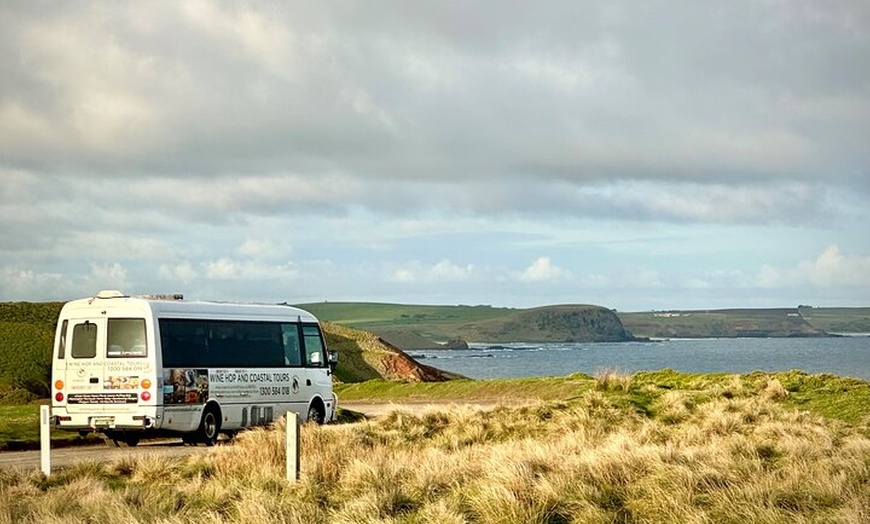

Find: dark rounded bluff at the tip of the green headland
[463,305,634,342]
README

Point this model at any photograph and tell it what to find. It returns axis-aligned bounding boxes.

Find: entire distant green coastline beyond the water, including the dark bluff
[300,302,870,350]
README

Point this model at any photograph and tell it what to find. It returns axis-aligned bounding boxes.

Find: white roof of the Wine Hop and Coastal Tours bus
[61,291,317,322]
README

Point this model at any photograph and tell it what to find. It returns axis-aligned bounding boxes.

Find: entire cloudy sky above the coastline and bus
[0,0,870,311]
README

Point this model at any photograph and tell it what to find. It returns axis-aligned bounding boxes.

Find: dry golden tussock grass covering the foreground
[0,377,870,524]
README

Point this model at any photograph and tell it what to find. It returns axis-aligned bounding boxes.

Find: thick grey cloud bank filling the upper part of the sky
[0,1,870,189]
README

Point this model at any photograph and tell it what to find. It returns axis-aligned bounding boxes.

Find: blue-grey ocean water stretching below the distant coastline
[408,335,870,381]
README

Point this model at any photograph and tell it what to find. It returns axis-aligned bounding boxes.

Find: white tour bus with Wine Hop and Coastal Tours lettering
[52,291,338,446]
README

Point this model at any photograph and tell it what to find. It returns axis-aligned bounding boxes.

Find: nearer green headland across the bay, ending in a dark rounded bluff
[299,302,631,349]
